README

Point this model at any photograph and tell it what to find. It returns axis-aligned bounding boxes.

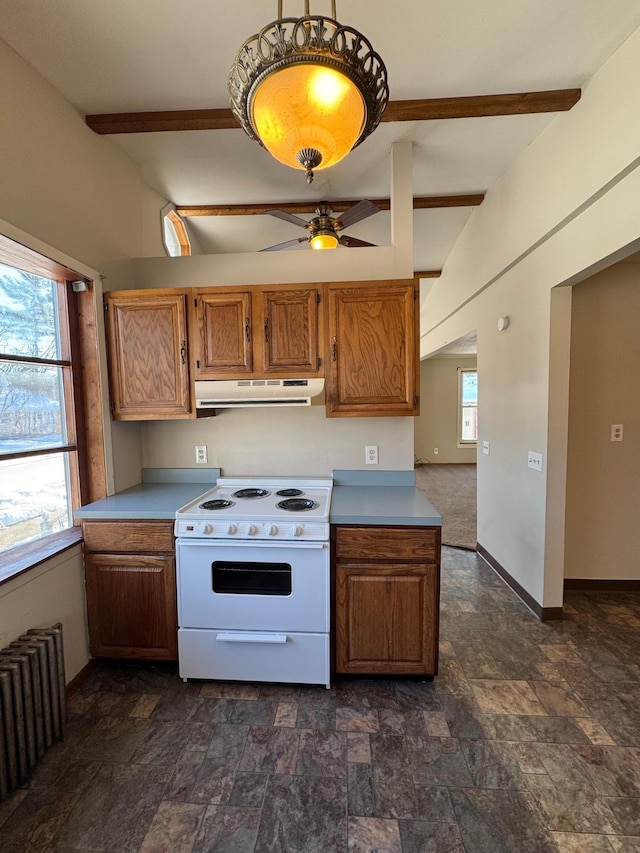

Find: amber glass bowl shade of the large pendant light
[251,62,366,176]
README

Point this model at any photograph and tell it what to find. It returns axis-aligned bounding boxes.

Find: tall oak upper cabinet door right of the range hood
[327,282,419,417]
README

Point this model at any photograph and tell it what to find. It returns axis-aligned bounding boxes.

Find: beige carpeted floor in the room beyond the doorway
[416,464,477,551]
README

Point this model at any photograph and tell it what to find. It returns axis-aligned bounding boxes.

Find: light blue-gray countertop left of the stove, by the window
[73,468,220,519]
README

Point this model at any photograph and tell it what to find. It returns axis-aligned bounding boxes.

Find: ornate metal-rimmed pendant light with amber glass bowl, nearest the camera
[229,0,389,183]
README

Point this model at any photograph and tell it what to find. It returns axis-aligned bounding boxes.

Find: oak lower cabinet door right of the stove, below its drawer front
[336,563,438,675]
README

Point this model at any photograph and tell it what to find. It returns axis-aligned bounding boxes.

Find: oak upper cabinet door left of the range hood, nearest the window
[105,290,193,420]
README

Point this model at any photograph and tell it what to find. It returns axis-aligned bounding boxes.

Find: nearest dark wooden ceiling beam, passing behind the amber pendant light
[85,89,581,134]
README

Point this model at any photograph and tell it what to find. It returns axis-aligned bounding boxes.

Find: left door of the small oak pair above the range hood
[194,288,253,379]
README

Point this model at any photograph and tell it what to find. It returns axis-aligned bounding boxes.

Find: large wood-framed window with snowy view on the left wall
[0,238,91,552]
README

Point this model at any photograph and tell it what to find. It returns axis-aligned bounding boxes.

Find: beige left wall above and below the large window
[0,42,165,680]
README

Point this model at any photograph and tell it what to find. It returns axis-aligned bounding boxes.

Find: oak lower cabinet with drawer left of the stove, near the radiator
[83,521,178,661]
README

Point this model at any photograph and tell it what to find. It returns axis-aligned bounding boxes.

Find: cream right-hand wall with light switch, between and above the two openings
[421,21,640,607]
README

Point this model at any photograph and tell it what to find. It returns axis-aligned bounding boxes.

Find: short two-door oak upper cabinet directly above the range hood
[192,285,320,379]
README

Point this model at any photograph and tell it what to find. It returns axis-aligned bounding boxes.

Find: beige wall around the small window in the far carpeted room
[415,355,477,464]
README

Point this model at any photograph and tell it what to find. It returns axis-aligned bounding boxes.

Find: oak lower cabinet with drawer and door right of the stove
[332,525,440,676]
